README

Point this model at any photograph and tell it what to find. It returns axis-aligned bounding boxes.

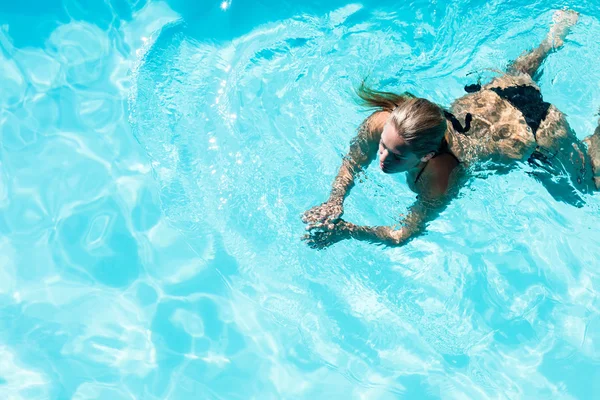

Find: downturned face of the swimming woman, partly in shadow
[379,122,420,174]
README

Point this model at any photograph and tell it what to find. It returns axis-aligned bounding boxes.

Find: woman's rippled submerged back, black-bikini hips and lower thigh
[449,73,594,204]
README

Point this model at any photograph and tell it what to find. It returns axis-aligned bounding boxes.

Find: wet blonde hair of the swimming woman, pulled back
[357,82,447,157]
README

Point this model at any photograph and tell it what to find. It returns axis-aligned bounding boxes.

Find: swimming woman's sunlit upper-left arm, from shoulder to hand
[302,111,390,224]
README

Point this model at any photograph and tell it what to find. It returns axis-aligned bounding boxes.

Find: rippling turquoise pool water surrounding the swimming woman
[0,0,600,400]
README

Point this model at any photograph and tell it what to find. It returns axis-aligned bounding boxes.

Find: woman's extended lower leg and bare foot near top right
[508,10,579,78]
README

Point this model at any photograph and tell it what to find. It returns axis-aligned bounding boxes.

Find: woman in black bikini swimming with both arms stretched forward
[302,10,600,248]
